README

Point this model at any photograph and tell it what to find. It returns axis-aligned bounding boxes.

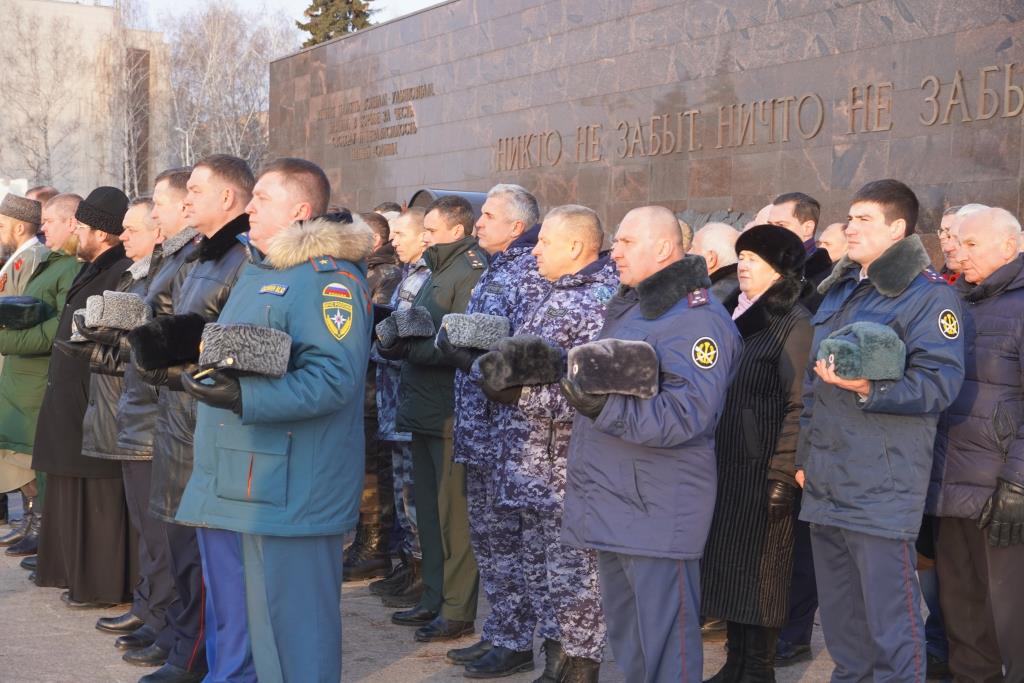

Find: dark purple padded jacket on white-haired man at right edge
[928,256,1024,519]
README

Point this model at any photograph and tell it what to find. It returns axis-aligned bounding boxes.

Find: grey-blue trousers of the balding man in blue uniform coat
[597,551,703,683]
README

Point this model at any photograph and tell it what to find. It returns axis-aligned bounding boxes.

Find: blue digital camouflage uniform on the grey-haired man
[455,226,551,651]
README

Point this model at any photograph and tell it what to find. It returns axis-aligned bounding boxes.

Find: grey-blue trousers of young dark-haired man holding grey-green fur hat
[811,524,927,683]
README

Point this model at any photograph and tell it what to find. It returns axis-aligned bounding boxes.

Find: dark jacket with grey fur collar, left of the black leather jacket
[117,227,199,460]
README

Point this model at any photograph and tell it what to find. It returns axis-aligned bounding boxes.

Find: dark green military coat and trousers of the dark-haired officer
[397,238,487,622]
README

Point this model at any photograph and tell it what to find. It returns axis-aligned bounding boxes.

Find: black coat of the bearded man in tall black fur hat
[32,244,131,478]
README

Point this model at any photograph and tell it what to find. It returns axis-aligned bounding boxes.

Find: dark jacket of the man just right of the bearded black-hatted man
[82,256,153,460]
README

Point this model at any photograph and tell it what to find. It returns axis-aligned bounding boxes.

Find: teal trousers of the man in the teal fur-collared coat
[242,533,345,683]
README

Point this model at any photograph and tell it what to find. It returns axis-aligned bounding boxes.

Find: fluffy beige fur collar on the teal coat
[266,216,374,270]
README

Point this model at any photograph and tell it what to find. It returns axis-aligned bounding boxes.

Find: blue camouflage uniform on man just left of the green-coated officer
[370,258,430,559]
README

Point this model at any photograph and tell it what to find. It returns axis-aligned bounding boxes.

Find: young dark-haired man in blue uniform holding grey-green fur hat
[797,179,964,683]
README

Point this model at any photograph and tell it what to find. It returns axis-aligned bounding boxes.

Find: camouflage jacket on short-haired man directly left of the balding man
[497,256,618,510]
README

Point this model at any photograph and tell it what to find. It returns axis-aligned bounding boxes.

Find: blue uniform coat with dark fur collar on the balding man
[562,256,741,559]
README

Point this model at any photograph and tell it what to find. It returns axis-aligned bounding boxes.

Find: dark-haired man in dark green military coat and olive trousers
[378,196,487,642]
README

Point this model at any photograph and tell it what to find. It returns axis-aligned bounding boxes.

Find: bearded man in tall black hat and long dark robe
[32,187,135,608]
